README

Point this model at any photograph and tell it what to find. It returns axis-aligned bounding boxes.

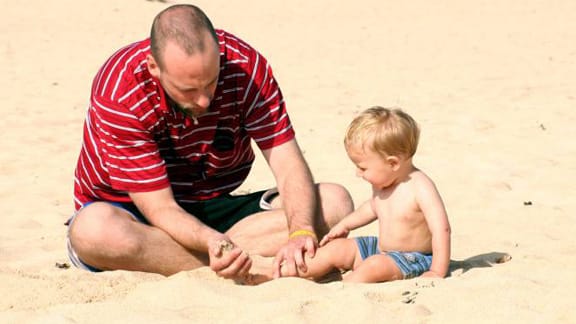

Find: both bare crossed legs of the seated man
[69,184,353,275]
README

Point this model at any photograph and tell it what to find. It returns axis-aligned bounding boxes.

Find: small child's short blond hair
[344,106,420,158]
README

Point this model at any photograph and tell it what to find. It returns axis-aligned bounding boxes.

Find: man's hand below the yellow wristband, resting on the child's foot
[273,235,318,278]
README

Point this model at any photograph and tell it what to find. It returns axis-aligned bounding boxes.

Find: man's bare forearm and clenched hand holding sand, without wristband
[130,188,251,278]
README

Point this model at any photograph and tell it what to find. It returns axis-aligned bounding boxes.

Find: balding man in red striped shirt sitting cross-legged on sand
[68,5,353,279]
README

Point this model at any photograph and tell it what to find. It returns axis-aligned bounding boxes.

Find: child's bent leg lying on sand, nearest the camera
[343,254,403,282]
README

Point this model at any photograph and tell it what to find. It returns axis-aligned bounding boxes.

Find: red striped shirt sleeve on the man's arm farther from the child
[91,96,170,192]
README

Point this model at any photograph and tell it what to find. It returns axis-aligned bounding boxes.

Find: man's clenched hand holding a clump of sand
[208,235,252,280]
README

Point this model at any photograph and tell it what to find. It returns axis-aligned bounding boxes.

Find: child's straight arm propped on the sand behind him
[416,177,451,278]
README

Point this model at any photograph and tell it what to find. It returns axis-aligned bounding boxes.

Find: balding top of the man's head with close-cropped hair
[150,4,218,68]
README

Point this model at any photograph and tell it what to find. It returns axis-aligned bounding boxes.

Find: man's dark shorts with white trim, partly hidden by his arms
[66,189,278,272]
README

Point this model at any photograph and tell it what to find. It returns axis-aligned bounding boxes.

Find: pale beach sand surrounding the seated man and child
[0,0,576,323]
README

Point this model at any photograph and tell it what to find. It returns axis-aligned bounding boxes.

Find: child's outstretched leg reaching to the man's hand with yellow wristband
[281,239,360,280]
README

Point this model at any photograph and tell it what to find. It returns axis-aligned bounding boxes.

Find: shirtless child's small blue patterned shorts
[355,236,432,279]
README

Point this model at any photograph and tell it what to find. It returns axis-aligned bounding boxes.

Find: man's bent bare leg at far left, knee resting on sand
[69,202,207,275]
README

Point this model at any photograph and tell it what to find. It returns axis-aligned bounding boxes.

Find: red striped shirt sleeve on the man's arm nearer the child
[245,51,295,150]
